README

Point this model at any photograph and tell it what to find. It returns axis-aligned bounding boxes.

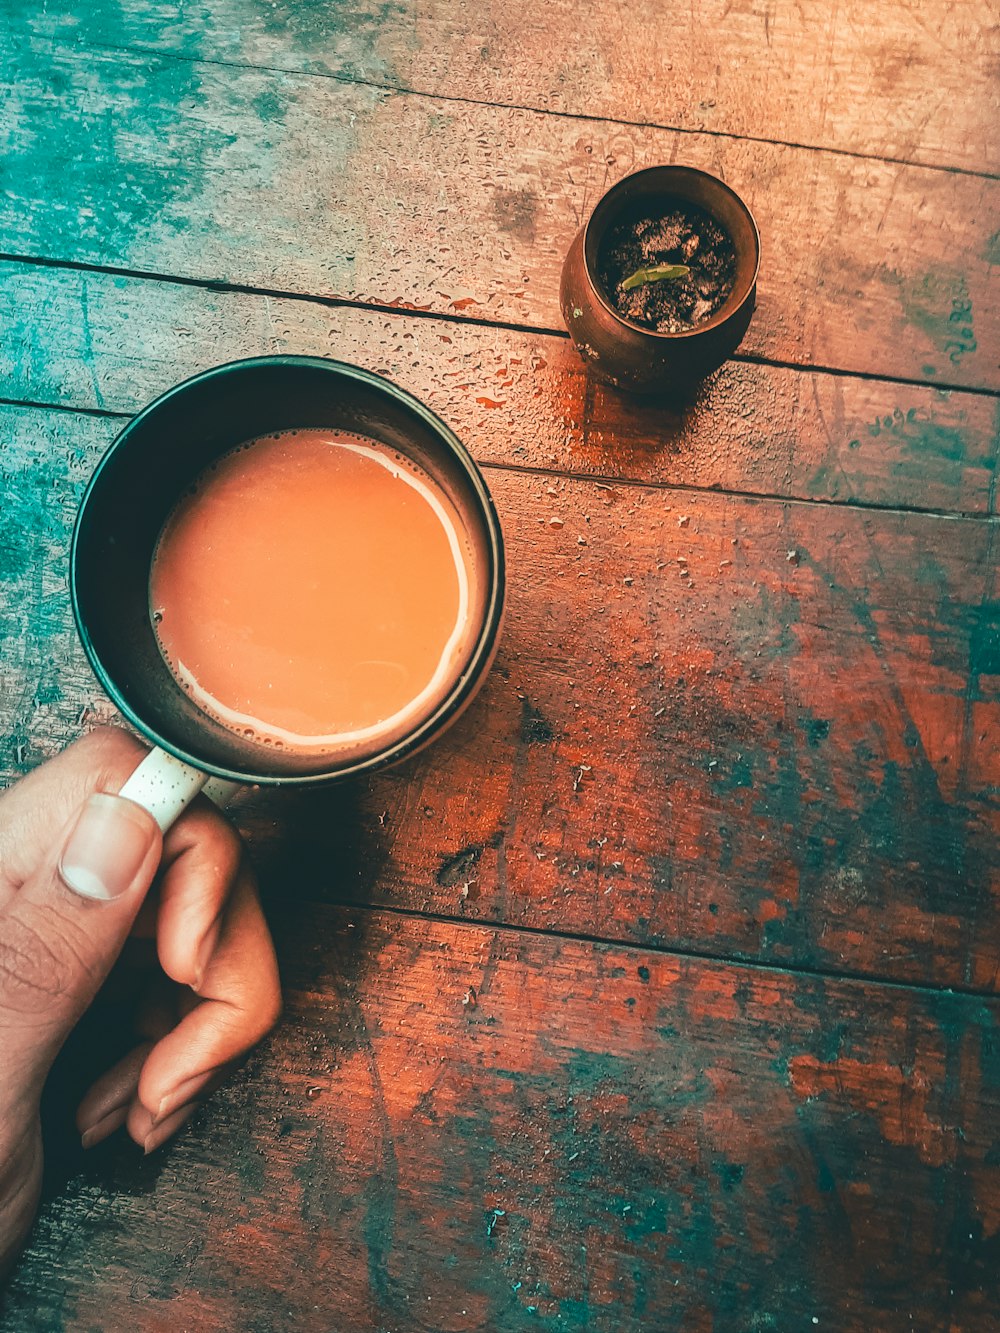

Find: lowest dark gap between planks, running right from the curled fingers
[301,890,1000,1002]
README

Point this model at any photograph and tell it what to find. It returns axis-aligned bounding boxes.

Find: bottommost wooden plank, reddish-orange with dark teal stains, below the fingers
[0,906,1000,1333]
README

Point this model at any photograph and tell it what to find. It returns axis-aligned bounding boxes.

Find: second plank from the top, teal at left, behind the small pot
[0,32,1000,388]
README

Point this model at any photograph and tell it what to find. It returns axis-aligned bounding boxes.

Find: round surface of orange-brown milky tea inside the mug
[149,429,472,750]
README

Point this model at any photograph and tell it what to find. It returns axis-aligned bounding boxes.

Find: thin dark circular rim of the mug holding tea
[69,353,507,786]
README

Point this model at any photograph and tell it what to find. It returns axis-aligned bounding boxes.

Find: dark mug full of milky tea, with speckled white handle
[71,356,504,828]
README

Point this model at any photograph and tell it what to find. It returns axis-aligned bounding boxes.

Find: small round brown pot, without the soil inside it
[560,167,760,393]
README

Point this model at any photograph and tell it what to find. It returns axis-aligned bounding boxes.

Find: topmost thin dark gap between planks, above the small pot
[87,41,1000,180]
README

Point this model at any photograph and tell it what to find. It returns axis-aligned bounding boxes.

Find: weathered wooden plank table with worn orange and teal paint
[0,0,1000,1333]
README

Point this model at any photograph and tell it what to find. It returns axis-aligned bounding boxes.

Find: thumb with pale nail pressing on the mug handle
[0,792,161,1097]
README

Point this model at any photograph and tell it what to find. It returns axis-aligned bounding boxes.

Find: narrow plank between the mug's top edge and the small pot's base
[0,264,1000,513]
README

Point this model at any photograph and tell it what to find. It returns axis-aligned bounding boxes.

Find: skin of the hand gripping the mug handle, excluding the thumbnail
[0,728,280,1277]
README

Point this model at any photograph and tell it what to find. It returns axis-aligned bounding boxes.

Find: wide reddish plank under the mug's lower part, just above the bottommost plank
[0,399,1000,992]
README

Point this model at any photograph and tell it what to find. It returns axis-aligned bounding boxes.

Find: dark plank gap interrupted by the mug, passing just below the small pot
[0,391,1000,524]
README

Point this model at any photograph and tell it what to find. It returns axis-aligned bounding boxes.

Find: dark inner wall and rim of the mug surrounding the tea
[69,356,504,784]
